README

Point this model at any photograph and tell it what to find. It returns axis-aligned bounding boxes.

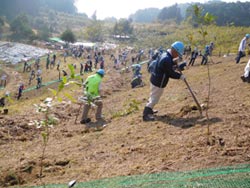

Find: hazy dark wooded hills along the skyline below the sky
[0,0,250,26]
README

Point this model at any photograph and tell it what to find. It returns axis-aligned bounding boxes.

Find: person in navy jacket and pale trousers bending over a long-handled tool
[143,41,185,121]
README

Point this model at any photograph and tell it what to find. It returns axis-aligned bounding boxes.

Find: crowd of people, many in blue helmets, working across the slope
[0,34,250,128]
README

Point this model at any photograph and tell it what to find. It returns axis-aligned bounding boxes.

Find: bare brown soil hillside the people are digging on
[0,51,250,187]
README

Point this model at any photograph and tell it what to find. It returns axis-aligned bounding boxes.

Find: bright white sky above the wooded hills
[75,0,247,20]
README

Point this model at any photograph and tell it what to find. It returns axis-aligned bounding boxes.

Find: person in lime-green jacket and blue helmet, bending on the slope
[80,69,105,124]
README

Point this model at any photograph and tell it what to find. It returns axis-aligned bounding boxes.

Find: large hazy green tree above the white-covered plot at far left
[10,14,35,40]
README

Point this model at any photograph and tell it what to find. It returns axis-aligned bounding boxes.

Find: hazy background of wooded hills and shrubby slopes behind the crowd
[0,0,250,52]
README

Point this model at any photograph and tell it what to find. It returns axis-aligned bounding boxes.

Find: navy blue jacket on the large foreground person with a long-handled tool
[150,52,181,88]
